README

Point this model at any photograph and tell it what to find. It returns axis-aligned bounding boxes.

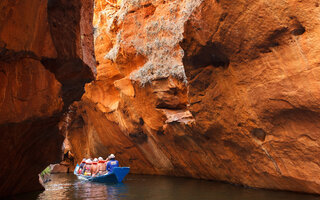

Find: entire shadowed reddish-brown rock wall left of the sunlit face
[0,0,95,196]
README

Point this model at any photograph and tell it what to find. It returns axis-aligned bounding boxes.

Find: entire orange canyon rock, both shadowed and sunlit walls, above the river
[0,0,320,196]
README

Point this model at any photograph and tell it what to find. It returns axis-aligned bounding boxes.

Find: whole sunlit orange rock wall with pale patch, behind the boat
[66,0,320,193]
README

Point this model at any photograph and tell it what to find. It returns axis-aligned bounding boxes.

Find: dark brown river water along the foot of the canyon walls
[12,174,320,200]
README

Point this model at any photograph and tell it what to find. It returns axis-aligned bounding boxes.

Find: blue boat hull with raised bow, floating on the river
[73,164,130,183]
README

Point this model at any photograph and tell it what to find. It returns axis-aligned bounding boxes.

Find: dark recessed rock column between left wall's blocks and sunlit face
[41,0,95,111]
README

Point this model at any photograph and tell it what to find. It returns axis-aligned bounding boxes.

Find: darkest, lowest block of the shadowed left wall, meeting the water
[0,115,64,195]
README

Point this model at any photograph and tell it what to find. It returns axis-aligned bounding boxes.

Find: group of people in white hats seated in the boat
[77,154,119,176]
